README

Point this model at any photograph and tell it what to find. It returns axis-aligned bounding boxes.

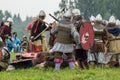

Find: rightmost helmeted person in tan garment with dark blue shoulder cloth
[103,16,120,67]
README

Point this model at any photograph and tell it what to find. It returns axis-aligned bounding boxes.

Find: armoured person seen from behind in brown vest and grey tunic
[50,10,79,71]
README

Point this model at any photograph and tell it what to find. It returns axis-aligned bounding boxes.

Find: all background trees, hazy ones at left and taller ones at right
[0,0,120,38]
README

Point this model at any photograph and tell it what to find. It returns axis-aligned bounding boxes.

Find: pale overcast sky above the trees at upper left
[0,0,61,22]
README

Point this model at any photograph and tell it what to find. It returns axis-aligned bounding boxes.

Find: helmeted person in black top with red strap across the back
[31,10,47,52]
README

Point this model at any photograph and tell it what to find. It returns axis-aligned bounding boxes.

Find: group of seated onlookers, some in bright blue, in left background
[6,32,28,52]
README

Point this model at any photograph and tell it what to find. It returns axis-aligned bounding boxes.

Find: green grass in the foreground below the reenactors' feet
[0,54,120,80]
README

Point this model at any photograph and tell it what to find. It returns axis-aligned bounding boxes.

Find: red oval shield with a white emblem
[79,22,94,50]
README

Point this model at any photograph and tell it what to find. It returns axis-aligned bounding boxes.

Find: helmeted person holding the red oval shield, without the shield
[72,9,89,69]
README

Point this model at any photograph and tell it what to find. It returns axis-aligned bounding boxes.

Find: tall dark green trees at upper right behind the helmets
[54,0,120,20]
